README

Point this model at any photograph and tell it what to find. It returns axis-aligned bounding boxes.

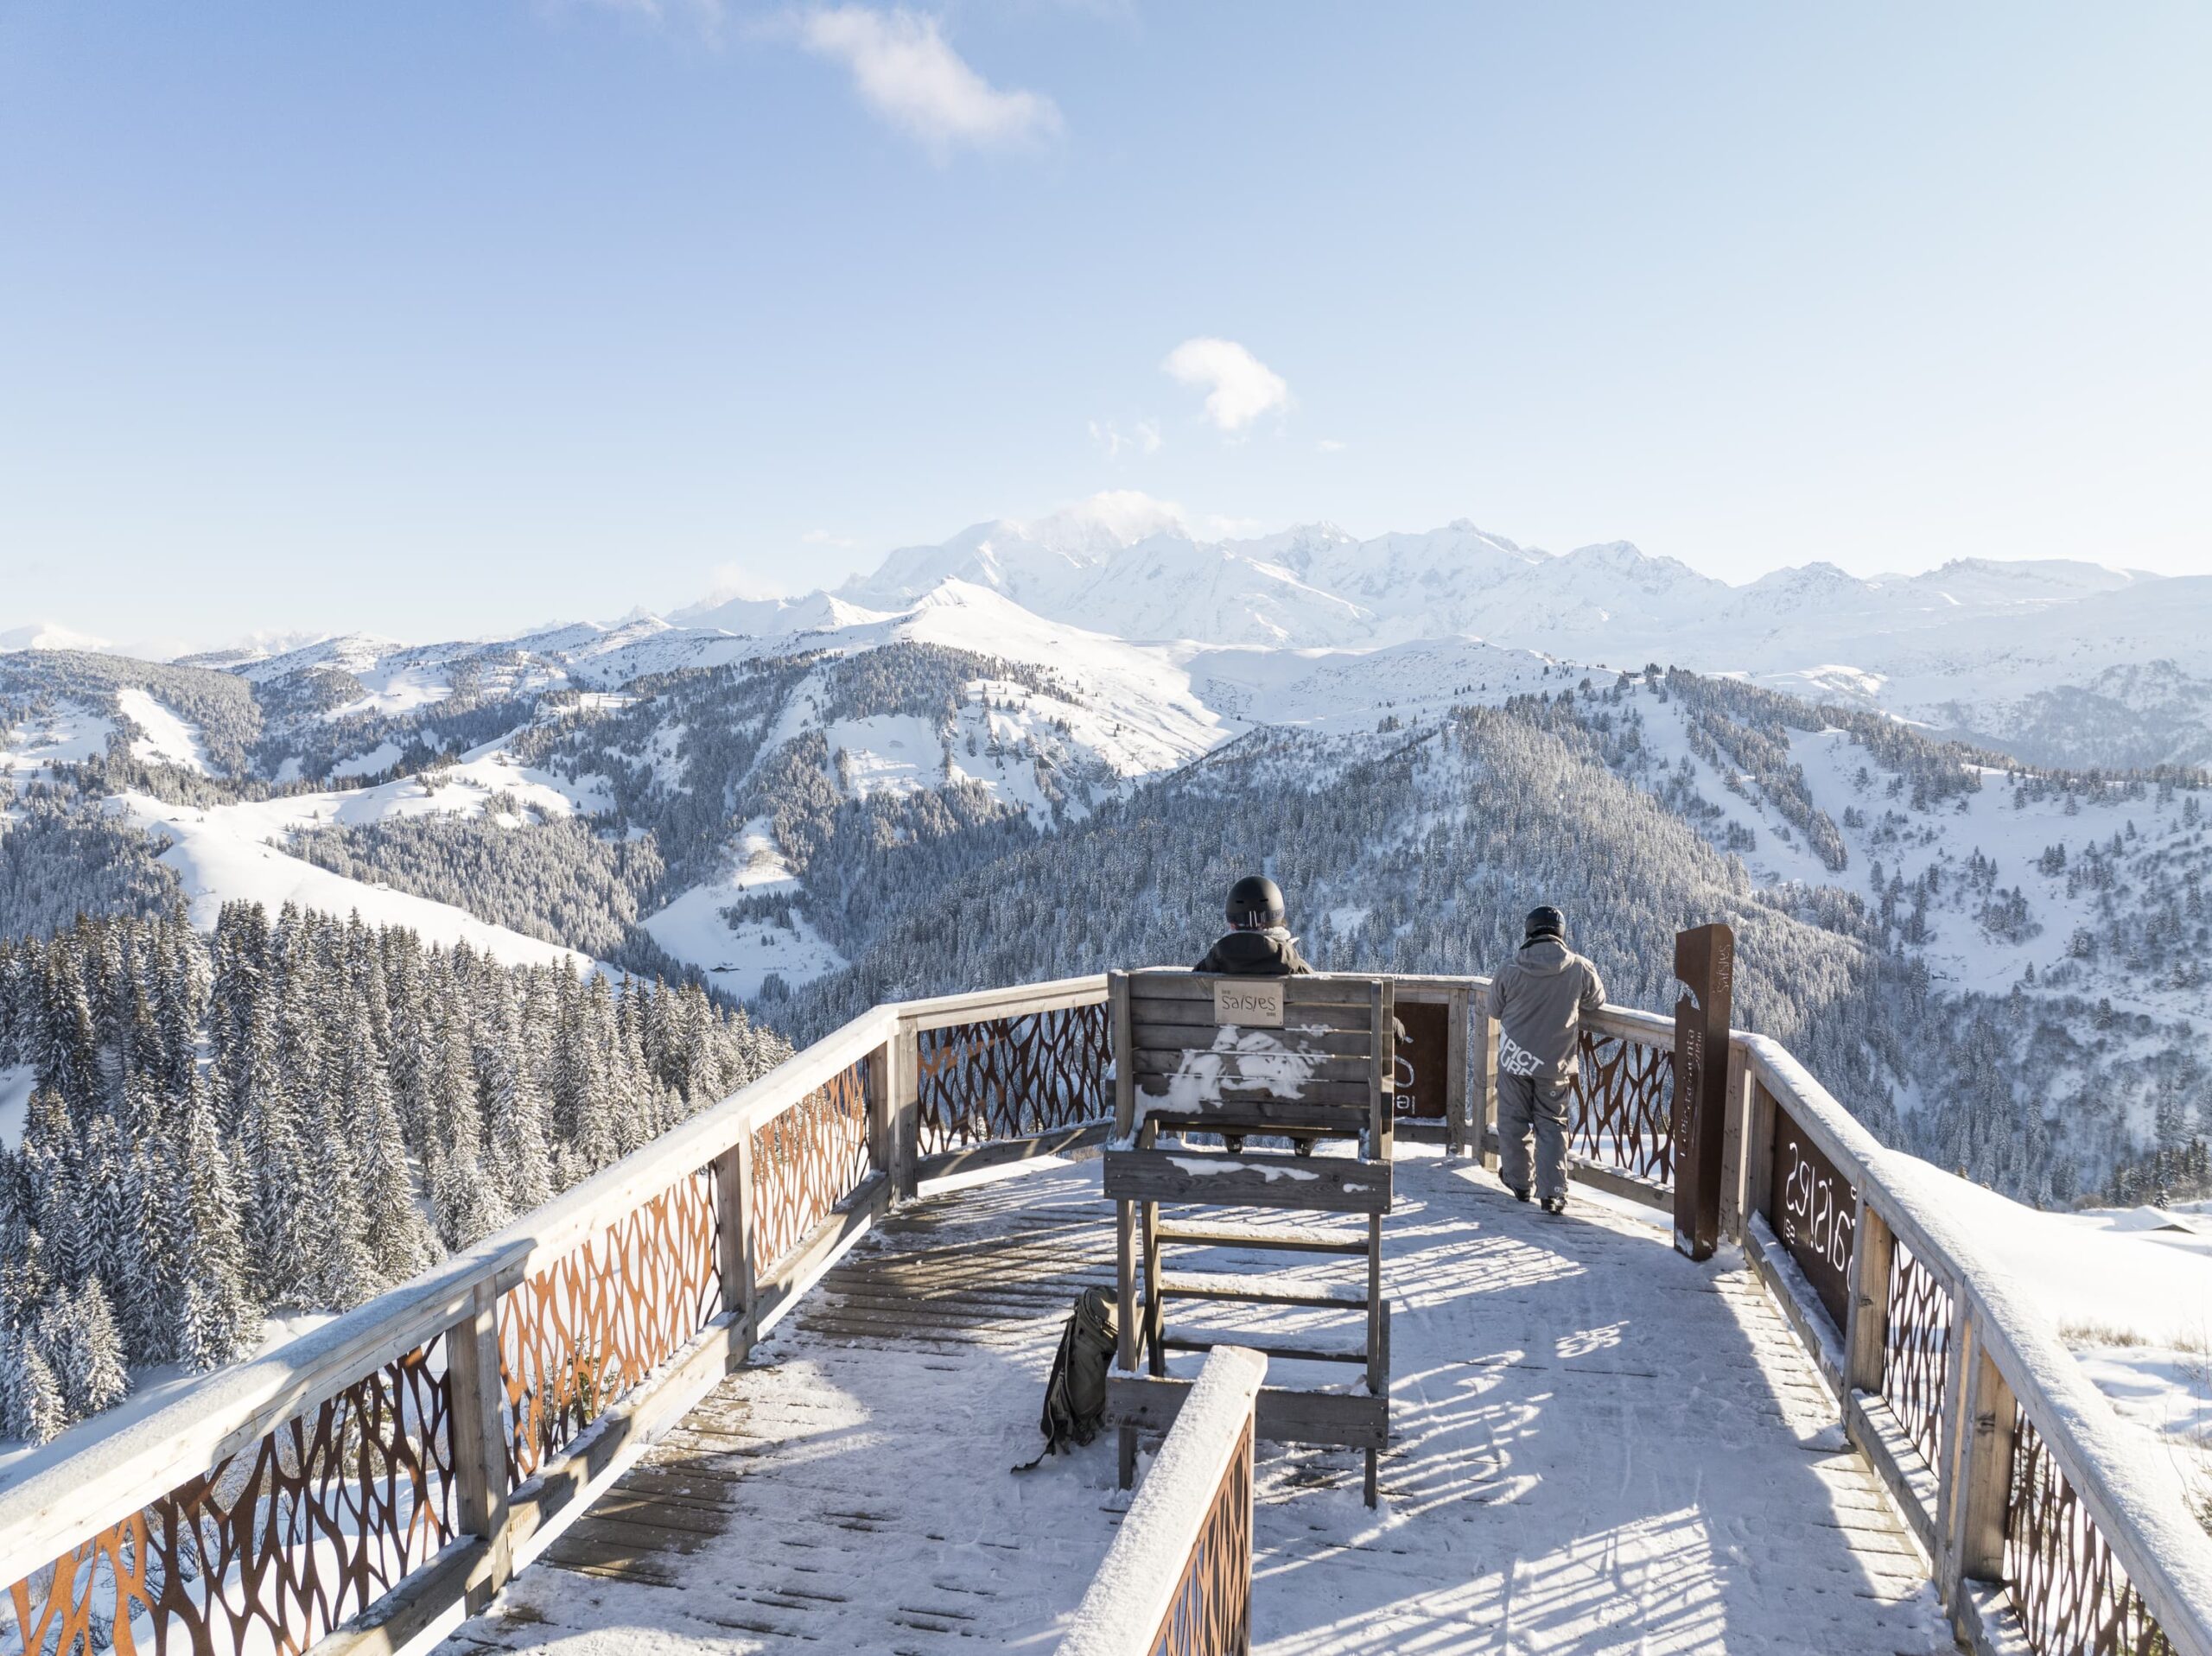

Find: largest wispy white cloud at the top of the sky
[791,7,1059,162]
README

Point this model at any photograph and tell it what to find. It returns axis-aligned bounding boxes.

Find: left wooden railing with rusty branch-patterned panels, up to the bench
[0,977,1106,1656]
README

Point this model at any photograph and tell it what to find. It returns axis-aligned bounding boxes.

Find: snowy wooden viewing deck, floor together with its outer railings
[0,963,2212,1656]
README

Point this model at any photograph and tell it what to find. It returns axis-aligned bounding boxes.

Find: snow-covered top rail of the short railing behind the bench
[1059,1347,1268,1656]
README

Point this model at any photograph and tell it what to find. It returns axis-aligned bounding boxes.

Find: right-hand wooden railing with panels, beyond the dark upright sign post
[1723,1031,2212,1656]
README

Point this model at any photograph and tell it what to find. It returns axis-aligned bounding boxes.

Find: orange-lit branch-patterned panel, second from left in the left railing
[500,1167,723,1488]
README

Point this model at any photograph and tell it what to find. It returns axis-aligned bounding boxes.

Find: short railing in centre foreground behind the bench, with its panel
[1059,1347,1268,1656]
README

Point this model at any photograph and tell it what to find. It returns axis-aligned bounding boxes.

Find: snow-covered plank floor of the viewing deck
[447,1150,1951,1656]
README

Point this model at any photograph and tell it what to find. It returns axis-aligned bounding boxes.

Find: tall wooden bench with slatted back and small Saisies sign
[1103,968,1395,1506]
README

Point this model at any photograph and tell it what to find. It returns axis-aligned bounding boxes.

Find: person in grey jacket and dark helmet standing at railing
[1491,904,1606,1214]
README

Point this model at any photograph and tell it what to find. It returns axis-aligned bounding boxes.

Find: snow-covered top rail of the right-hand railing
[1730,1031,2212,1652]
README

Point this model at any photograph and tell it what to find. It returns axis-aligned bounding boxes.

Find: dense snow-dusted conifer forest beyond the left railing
[0,898,787,1442]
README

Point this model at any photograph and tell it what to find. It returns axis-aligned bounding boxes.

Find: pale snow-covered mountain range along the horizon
[17,493,2212,767]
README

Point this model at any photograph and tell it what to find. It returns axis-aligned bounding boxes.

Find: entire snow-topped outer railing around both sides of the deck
[0,955,2212,1656]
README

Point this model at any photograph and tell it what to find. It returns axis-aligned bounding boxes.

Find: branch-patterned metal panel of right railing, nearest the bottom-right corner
[2004,1406,2174,1656]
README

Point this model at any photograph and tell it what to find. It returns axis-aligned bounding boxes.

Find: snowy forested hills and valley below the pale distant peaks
[0,584,2212,1435]
